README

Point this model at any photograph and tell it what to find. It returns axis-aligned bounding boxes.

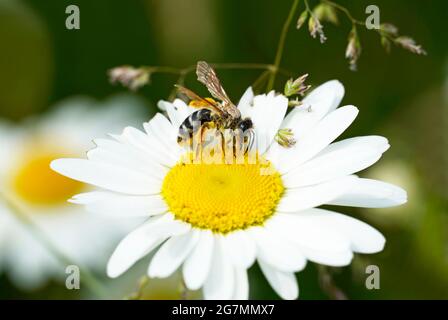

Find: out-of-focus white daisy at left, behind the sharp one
[0,96,143,289]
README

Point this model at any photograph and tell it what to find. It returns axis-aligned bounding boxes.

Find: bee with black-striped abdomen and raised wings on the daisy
[176,61,254,156]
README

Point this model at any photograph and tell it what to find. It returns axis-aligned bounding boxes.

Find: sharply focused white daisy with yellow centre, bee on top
[52,81,406,299]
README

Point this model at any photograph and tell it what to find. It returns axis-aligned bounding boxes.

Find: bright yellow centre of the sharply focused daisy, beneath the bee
[162,163,284,233]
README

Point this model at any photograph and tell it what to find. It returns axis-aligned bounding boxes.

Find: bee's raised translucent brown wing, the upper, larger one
[196,61,236,108]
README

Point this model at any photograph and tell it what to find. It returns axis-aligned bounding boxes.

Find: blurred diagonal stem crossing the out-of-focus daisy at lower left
[0,193,107,298]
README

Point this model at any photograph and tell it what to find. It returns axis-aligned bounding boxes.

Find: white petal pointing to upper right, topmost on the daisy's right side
[282,80,344,140]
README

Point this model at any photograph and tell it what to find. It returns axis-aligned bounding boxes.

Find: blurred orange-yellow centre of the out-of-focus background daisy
[12,154,84,205]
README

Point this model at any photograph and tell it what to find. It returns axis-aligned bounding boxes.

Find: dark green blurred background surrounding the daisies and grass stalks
[0,0,448,299]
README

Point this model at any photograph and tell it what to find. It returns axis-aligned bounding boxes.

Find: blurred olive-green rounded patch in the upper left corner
[0,1,53,118]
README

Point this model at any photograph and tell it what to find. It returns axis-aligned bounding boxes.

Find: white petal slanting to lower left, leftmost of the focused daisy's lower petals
[107,215,190,278]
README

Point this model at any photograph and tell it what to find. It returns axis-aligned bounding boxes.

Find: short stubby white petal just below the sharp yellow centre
[223,231,255,269]
